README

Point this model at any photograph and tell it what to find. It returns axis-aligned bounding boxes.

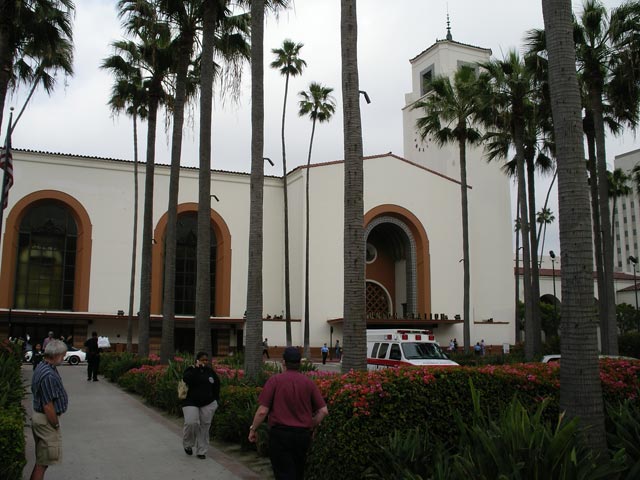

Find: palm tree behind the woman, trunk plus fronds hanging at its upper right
[194,0,249,353]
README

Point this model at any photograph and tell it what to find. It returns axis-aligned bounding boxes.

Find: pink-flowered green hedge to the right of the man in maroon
[307,361,640,479]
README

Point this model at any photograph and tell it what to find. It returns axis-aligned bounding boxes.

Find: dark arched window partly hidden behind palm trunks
[175,212,216,315]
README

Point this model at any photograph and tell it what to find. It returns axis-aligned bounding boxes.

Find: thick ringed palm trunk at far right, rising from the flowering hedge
[542,0,606,453]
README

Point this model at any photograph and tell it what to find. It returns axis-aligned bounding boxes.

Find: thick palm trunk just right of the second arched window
[245,0,264,378]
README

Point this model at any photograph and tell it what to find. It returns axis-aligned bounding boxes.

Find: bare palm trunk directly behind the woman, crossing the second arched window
[194,0,216,355]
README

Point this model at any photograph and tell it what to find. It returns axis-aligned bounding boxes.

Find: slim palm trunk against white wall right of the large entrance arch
[458,138,471,352]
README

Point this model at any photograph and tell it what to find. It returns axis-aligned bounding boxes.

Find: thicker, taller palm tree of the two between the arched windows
[118,0,171,357]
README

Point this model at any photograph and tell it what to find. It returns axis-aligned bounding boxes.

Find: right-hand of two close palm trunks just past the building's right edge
[526,158,542,355]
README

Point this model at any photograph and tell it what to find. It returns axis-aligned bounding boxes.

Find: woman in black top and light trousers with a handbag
[182,352,220,459]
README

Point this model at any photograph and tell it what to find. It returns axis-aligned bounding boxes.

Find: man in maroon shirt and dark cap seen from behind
[249,347,329,480]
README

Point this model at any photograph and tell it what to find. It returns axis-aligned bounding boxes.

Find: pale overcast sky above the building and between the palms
[5,0,640,255]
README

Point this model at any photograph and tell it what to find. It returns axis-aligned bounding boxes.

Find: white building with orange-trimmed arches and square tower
[0,35,515,354]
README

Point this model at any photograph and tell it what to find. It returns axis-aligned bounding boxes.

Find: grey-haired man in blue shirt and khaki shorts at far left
[30,340,69,480]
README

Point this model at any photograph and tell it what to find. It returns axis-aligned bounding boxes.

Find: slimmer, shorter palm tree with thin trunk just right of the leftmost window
[101,42,149,352]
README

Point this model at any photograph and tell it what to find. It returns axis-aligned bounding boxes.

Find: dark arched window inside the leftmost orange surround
[14,201,78,310]
